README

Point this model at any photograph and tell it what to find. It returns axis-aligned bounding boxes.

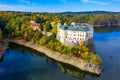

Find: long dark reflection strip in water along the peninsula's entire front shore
[6,43,99,80]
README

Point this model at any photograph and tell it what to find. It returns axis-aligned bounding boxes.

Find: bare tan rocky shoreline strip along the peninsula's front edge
[11,40,103,75]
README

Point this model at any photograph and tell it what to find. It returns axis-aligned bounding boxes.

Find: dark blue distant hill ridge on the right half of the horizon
[59,11,120,14]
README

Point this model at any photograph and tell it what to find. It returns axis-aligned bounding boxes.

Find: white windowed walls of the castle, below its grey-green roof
[57,23,93,46]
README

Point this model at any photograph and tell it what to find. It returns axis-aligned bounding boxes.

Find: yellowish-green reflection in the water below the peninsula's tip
[58,63,99,80]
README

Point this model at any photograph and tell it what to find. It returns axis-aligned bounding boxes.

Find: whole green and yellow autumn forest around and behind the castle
[0,11,120,64]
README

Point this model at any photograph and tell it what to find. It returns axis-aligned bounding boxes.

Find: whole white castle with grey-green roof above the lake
[57,23,94,46]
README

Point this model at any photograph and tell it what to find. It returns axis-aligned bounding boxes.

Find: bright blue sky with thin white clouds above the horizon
[0,0,120,12]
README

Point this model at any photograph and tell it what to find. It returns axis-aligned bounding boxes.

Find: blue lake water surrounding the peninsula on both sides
[0,27,120,80]
